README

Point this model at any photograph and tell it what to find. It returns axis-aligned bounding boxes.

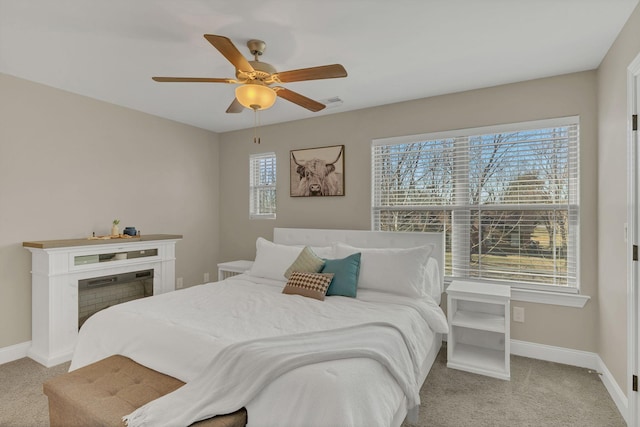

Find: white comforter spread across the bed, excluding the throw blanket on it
[70,275,447,427]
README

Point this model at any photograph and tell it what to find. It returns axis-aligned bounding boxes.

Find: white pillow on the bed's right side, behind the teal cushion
[334,243,434,297]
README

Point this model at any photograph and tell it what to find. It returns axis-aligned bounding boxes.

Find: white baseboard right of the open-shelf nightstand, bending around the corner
[511,340,629,423]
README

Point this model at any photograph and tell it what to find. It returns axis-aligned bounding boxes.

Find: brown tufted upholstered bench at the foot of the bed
[43,355,247,427]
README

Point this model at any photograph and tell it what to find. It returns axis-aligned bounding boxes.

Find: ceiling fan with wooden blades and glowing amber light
[153,34,347,113]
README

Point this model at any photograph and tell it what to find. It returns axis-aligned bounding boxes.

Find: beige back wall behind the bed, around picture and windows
[220,71,598,352]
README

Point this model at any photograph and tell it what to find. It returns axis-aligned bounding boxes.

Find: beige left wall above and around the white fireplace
[0,74,219,349]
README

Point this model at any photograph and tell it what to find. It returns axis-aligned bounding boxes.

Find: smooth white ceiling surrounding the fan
[0,0,638,132]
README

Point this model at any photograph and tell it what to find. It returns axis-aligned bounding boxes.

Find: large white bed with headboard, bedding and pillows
[70,228,447,427]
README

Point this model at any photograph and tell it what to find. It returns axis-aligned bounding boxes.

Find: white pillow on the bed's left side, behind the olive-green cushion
[249,237,302,281]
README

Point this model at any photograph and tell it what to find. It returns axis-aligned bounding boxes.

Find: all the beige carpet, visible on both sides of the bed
[0,346,626,427]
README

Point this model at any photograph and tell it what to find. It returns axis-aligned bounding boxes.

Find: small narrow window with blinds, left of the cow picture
[249,153,276,219]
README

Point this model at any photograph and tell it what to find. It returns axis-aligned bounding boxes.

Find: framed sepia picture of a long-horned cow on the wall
[289,145,344,197]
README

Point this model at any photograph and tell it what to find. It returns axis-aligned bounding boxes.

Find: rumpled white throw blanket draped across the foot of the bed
[123,322,420,427]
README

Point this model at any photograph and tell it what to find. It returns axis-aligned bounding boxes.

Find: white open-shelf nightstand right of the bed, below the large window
[447,281,511,380]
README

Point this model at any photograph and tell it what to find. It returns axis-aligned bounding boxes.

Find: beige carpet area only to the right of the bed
[403,346,626,427]
